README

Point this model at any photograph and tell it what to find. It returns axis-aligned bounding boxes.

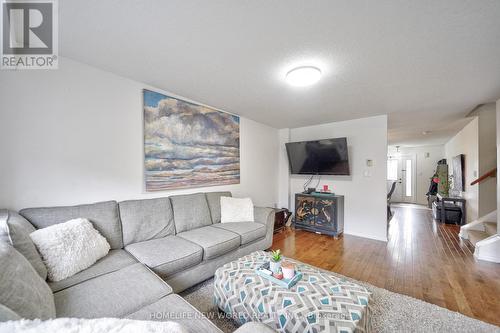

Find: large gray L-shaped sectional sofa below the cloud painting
[0,192,274,332]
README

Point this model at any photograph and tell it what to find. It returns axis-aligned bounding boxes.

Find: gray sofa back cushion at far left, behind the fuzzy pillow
[0,209,47,280]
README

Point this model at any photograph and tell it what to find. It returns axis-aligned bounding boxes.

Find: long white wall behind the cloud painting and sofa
[0,58,279,209]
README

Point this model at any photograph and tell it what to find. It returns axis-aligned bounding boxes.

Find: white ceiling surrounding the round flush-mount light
[59,0,500,145]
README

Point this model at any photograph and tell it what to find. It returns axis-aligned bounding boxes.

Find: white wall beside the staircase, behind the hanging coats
[444,117,479,222]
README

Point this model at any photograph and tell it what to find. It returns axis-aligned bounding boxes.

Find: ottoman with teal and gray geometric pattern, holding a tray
[214,251,371,333]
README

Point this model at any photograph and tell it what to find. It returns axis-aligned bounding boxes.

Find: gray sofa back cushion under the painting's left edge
[118,198,175,246]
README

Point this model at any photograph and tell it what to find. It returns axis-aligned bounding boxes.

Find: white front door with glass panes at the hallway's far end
[387,155,417,203]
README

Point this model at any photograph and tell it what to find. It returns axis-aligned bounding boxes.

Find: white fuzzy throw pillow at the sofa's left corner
[30,218,110,281]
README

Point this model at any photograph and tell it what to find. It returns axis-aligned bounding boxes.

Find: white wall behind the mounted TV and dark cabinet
[280,115,387,241]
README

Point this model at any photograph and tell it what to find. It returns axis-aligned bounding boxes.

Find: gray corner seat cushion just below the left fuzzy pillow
[49,250,137,292]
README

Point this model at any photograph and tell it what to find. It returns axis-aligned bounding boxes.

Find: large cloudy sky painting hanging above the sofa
[144,90,240,191]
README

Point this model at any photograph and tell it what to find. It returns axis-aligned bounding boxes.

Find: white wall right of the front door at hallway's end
[388,145,445,205]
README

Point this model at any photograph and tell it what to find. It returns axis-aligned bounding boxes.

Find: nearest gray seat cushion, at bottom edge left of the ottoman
[126,294,221,333]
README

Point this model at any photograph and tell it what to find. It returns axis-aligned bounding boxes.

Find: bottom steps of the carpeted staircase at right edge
[459,211,500,263]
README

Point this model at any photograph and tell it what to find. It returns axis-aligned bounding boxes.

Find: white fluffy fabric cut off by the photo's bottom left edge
[0,318,188,333]
